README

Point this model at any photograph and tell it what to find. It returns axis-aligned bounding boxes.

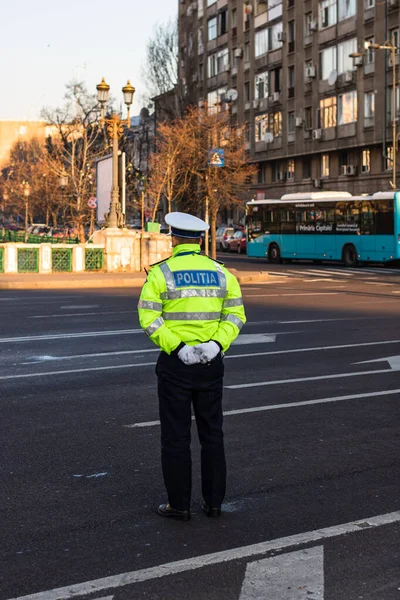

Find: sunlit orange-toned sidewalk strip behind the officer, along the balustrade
[0,269,277,290]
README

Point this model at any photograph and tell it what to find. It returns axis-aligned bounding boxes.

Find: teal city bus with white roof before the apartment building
[246,192,400,266]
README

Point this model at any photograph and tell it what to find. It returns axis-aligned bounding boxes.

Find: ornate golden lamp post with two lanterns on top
[96,77,135,228]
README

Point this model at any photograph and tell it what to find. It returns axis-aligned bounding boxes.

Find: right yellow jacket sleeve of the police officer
[212,269,246,352]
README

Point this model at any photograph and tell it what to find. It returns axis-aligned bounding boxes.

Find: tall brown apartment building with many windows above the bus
[179,0,400,199]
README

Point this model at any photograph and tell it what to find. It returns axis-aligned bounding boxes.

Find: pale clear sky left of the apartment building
[0,0,178,120]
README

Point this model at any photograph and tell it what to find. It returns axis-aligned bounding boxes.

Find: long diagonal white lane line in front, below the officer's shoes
[9,511,400,600]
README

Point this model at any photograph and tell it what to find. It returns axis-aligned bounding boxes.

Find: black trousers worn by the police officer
[156,352,226,510]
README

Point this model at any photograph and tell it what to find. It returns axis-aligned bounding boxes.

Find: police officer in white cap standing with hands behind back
[138,212,246,521]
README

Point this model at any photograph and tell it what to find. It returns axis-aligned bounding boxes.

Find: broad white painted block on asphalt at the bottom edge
[239,546,324,600]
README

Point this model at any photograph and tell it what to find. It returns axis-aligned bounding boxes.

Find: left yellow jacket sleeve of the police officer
[138,267,181,354]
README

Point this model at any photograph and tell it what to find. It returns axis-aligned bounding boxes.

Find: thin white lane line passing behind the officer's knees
[124,386,400,429]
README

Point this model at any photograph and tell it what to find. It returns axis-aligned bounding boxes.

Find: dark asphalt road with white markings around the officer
[0,257,400,600]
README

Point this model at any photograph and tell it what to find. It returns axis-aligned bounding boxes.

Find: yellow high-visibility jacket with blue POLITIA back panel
[138,244,246,354]
